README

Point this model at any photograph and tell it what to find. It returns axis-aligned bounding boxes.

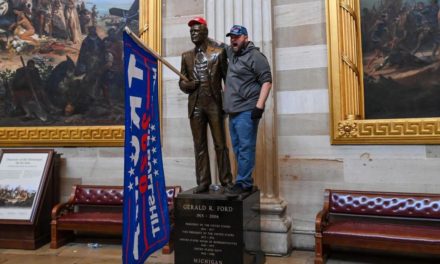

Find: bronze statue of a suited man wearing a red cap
[179,17,232,193]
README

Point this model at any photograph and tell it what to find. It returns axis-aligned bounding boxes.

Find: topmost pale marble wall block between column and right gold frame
[273,1,325,28]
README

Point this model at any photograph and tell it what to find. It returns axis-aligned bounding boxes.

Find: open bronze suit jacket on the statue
[179,40,228,117]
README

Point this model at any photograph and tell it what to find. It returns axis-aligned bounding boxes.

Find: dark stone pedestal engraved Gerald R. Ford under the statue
[174,189,265,264]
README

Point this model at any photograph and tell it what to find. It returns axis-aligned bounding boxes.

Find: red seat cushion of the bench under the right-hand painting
[323,219,440,246]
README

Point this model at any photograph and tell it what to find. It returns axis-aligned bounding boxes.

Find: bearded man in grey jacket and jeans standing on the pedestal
[224,25,272,196]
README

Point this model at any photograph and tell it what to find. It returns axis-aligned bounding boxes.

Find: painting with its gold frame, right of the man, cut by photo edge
[326,0,440,144]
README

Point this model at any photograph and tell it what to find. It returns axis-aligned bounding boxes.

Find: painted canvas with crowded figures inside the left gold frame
[0,0,139,127]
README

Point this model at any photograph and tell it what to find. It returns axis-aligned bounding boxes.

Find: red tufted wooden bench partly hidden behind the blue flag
[50,185,181,254]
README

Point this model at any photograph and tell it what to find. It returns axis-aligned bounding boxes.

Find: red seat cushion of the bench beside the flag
[58,212,122,225]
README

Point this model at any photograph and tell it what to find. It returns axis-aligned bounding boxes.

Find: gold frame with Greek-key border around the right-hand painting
[326,0,440,144]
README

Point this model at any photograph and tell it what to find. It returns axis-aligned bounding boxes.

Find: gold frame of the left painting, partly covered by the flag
[0,0,162,147]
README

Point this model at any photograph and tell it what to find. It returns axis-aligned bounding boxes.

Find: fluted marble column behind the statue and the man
[205,0,292,255]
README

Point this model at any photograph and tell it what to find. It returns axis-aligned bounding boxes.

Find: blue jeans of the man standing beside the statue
[229,111,260,189]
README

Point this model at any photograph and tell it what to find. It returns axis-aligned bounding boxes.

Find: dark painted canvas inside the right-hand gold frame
[360,0,440,119]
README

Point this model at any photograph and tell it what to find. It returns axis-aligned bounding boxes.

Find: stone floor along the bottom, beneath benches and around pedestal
[0,243,440,264]
